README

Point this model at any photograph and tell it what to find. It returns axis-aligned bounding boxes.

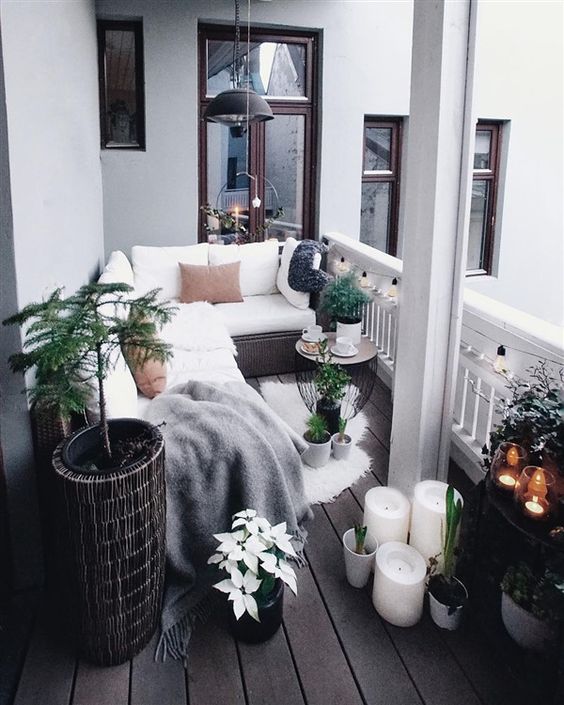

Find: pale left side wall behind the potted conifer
[0,0,103,588]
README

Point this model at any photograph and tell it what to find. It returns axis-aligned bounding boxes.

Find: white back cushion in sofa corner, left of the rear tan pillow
[131,242,209,300]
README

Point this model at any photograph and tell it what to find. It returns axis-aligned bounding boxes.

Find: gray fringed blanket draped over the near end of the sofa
[145,382,311,660]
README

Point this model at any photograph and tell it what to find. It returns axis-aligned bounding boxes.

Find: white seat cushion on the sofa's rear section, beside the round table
[215,294,315,335]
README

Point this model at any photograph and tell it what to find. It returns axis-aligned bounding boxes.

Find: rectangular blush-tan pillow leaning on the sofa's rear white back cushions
[178,262,243,304]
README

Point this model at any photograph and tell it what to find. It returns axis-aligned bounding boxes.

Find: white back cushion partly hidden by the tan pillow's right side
[209,240,279,296]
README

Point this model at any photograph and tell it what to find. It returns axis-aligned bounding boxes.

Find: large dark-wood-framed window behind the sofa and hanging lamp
[199,24,318,242]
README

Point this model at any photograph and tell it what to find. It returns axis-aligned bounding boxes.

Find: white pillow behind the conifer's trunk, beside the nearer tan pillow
[86,349,137,424]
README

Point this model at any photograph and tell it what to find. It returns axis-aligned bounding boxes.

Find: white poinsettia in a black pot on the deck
[208,509,297,643]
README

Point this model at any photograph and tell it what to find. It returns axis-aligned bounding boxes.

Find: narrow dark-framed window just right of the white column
[466,120,502,276]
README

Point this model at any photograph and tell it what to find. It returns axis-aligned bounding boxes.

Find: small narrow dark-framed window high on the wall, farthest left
[97,20,145,149]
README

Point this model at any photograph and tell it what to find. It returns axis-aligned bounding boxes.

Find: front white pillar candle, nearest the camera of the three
[372,541,427,627]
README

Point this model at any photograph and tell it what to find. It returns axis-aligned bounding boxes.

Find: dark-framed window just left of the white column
[360,117,402,256]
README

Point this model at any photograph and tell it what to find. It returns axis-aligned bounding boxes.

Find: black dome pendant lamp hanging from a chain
[204,0,274,135]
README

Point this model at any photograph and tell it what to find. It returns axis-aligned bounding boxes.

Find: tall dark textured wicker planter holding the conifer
[53,419,166,666]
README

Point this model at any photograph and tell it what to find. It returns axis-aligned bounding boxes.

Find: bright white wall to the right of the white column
[467,0,564,326]
